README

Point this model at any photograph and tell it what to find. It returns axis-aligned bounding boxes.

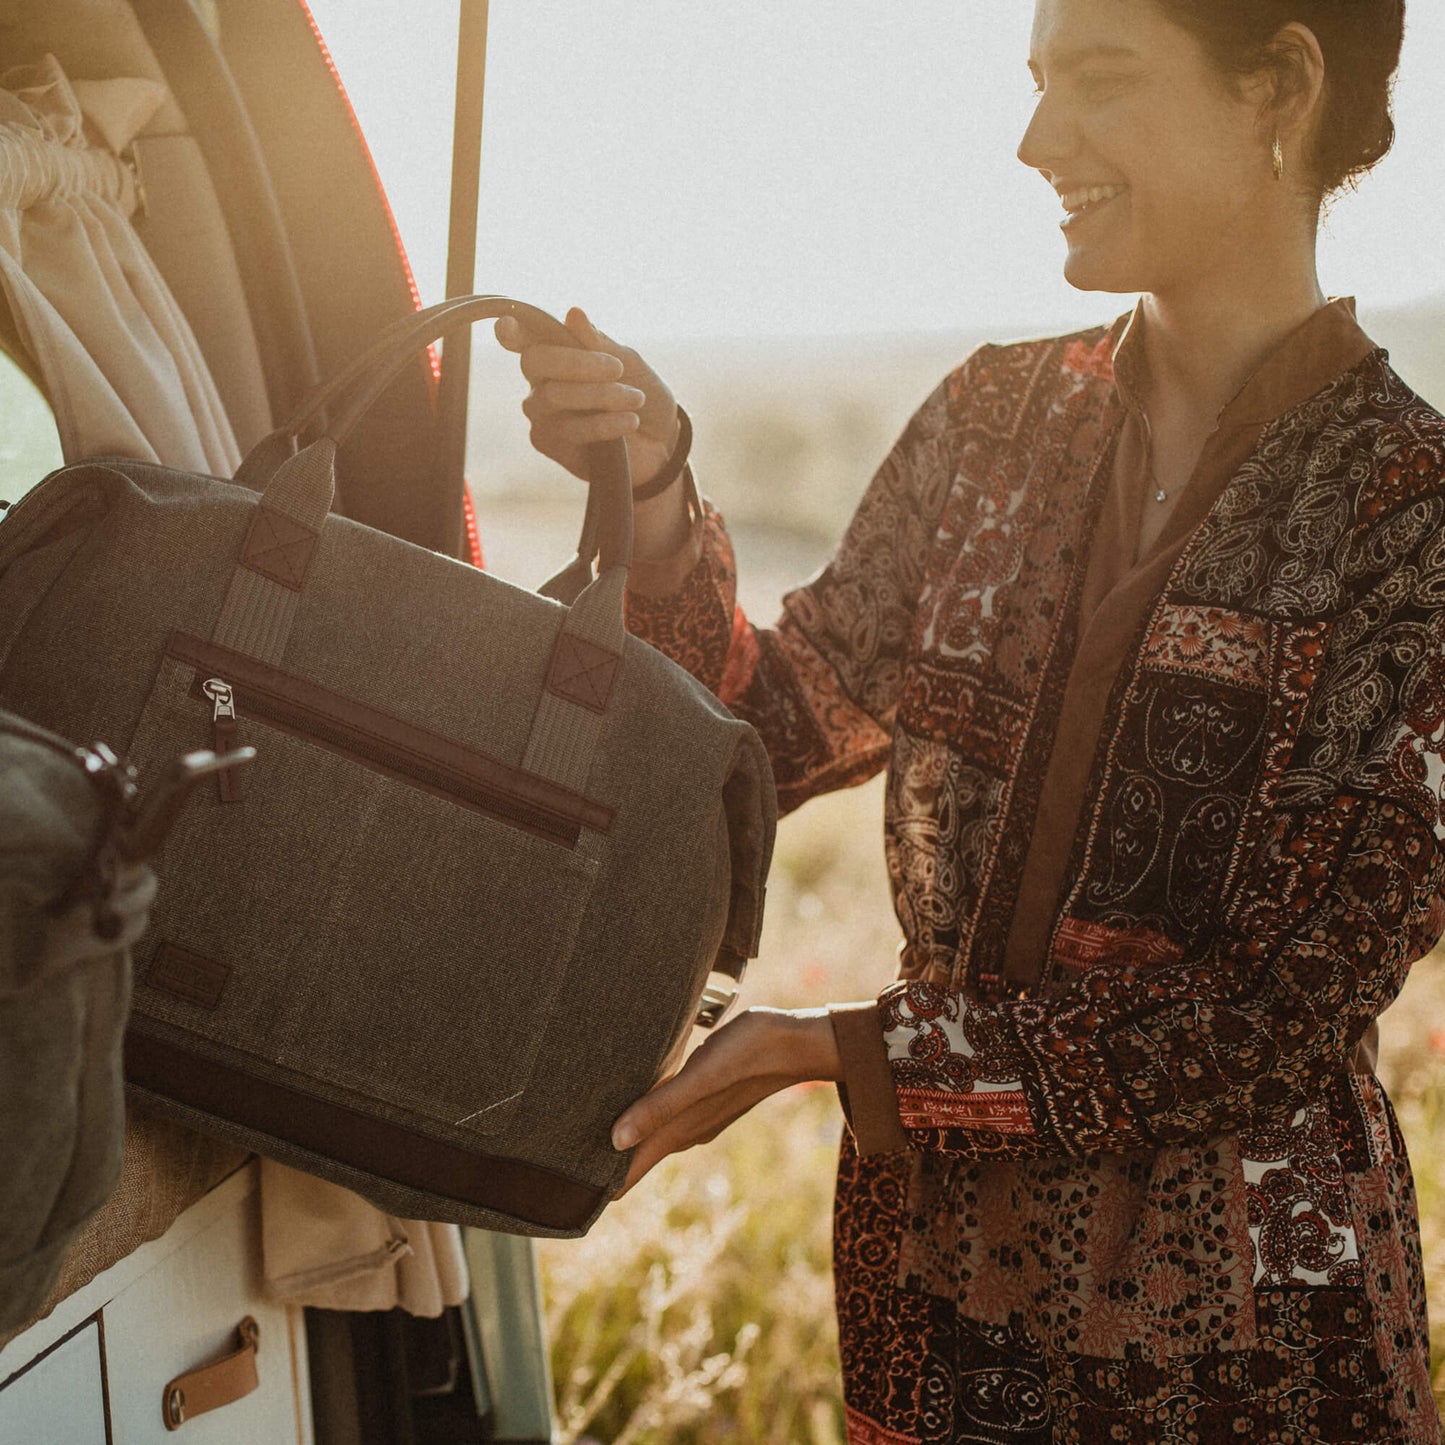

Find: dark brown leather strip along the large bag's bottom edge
[126,1026,605,1230]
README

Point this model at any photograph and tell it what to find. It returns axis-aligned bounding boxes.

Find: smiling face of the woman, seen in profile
[1019,0,1279,295]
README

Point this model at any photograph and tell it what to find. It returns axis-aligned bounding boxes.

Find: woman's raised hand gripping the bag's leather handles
[497,306,679,487]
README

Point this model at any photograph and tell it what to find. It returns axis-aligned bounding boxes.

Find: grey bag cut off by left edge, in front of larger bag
[0,711,153,1332]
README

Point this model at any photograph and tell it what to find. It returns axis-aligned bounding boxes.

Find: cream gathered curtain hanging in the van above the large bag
[0,55,240,477]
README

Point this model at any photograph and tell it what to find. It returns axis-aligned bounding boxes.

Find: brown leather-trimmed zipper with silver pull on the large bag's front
[166,631,613,848]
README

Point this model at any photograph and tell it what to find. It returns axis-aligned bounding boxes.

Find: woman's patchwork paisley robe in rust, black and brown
[630,302,1445,1445]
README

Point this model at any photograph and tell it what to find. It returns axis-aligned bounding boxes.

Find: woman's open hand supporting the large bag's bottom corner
[613,1009,842,1198]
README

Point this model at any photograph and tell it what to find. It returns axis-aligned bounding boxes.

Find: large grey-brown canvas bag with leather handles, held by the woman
[0,298,776,1235]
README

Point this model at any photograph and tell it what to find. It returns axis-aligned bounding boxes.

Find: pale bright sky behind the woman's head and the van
[311,0,1445,340]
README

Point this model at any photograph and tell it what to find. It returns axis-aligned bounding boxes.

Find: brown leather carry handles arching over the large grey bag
[233,296,633,603]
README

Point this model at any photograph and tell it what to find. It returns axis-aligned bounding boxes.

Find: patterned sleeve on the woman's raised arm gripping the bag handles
[627,363,967,811]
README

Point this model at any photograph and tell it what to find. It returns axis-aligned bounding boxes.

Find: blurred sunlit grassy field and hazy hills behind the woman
[482,303,1445,1445]
